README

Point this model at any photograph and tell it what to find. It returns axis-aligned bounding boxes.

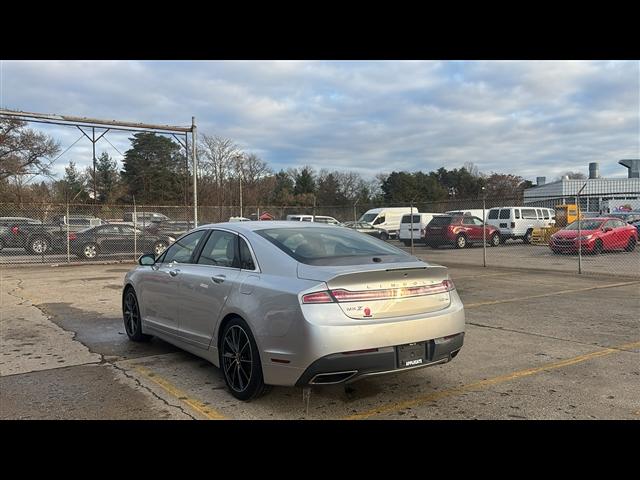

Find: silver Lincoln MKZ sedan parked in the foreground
[122,221,465,400]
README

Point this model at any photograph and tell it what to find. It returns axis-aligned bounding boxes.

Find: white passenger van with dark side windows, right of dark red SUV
[487,207,556,243]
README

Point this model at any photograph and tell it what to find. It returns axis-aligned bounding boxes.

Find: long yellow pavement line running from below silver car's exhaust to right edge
[343,342,640,420]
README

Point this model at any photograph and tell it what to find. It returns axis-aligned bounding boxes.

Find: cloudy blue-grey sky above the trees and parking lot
[0,61,640,181]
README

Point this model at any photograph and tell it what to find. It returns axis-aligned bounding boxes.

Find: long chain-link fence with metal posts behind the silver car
[0,186,640,277]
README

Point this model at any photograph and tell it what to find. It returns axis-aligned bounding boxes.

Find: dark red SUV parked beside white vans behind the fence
[424,215,500,248]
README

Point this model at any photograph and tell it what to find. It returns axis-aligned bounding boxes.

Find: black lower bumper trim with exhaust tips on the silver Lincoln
[296,332,464,387]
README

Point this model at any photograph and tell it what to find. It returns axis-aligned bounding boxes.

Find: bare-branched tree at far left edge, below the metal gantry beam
[0,119,60,180]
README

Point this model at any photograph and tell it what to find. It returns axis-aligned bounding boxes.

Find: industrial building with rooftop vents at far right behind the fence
[524,159,640,213]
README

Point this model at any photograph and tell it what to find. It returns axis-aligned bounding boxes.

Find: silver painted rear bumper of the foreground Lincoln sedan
[258,290,465,386]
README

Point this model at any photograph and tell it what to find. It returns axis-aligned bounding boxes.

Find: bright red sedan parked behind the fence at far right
[549,217,638,255]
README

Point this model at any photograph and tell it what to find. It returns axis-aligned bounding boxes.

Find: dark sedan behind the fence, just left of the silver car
[69,223,176,260]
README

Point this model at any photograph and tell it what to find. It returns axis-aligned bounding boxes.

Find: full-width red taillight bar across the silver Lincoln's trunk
[302,280,456,304]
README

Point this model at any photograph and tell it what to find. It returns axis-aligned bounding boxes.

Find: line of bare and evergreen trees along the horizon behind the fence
[0,120,544,206]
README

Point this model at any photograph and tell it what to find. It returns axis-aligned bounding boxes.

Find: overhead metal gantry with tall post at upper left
[0,109,198,227]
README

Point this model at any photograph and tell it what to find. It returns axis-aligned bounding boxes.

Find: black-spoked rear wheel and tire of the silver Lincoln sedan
[220,317,269,401]
